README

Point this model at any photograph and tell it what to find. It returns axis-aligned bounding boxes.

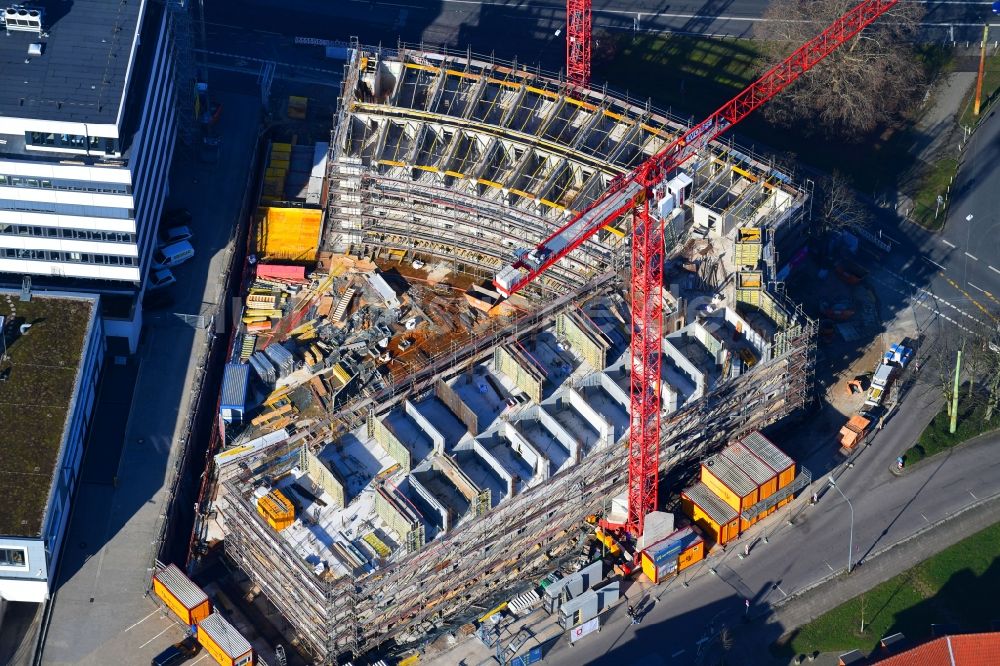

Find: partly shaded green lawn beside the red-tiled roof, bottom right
[772,523,1000,658]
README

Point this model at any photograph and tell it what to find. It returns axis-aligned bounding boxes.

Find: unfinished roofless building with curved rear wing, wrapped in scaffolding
[214,48,814,663]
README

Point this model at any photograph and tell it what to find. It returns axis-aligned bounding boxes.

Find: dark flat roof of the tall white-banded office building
[0,0,146,124]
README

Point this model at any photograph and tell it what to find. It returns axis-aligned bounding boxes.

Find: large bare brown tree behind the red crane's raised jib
[754,0,924,139]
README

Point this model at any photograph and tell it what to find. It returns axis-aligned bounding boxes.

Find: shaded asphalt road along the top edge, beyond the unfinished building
[206,0,1000,70]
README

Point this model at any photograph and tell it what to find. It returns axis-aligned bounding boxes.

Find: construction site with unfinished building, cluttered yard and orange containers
[178,35,828,664]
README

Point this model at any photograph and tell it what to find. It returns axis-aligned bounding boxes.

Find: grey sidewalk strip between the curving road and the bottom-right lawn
[733,486,1000,666]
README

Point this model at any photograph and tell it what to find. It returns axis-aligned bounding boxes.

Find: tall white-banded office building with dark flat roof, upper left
[0,0,176,350]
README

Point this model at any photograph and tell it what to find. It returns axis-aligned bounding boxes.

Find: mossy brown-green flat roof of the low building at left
[0,290,96,537]
